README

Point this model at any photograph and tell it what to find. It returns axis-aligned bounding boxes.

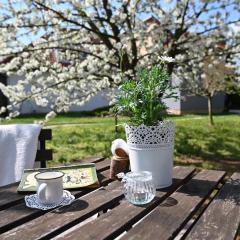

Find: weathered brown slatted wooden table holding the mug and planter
[0,158,240,240]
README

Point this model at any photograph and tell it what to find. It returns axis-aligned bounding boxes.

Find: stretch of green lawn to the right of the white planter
[172,115,240,172]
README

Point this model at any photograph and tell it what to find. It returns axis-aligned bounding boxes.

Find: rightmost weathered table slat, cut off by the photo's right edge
[186,173,240,240]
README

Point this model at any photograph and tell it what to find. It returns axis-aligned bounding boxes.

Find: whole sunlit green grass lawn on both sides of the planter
[2,113,240,171]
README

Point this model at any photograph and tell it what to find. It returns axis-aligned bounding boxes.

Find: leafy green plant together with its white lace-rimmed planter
[116,64,176,188]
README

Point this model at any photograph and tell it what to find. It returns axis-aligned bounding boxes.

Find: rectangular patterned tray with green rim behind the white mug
[17,163,99,192]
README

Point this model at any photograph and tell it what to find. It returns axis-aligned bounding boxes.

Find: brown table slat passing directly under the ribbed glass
[54,167,195,240]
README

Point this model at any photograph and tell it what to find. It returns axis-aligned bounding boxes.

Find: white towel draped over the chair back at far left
[0,124,41,186]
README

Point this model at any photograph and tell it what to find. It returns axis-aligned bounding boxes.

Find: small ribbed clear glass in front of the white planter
[122,171,156,205]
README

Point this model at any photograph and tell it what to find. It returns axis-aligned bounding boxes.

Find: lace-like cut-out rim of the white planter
[125,121,175,148]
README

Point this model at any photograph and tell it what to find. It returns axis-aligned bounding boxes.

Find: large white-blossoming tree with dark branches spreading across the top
[0,0,240,120]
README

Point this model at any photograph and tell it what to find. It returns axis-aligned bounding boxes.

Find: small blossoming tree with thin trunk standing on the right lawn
[180,47,236,125]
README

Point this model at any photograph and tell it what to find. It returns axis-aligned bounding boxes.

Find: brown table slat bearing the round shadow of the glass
[122,170,225,240]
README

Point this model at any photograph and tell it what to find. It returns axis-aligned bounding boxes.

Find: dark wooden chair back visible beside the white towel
[35,129,53,168]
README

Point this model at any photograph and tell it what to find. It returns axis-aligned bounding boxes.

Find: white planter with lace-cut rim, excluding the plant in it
[125,122,175,188]
